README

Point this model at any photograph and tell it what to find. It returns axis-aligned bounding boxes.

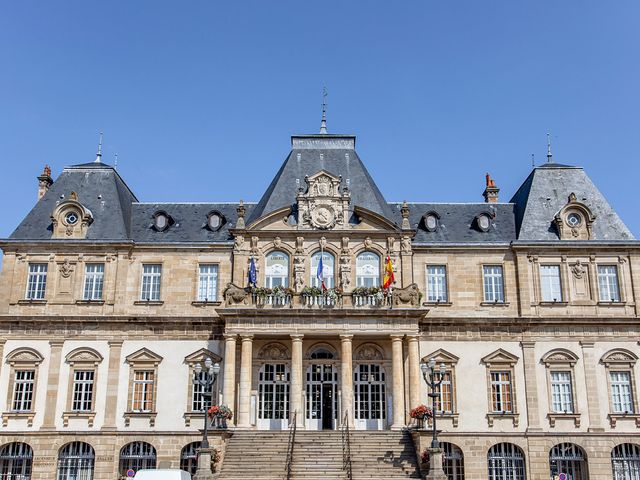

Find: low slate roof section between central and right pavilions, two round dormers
[389,202,516,245]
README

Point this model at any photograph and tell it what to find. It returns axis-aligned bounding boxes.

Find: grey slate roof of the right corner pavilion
[511,163,634,241]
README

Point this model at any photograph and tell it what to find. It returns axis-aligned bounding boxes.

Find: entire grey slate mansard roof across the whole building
[3,134,634,245]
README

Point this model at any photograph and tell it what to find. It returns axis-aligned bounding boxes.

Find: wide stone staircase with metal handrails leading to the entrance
[219,430,421,480]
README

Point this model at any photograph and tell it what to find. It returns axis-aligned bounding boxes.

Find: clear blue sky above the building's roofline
[0,0,640,266]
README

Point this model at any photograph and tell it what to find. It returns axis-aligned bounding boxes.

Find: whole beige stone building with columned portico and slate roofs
[0,128,640,480]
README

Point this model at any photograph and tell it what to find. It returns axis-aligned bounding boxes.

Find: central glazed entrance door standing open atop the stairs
[305,363,338,430]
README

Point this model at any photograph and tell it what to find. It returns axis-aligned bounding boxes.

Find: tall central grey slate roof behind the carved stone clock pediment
[247,135,394,223]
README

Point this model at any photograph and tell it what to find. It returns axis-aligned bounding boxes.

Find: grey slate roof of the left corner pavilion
[9,162,137,241]
